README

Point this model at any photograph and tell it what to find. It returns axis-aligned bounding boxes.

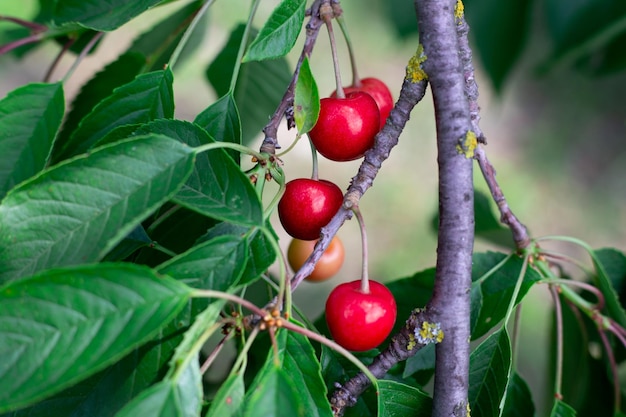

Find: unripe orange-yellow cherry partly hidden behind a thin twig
[287,236,345,282]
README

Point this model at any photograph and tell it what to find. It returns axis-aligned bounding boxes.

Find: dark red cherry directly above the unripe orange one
[278,178,343,240]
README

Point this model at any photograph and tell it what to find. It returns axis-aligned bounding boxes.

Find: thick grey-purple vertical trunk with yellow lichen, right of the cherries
[415,0,476,417]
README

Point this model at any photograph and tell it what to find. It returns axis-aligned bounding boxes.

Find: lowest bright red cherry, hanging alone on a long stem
[326,280,397,352]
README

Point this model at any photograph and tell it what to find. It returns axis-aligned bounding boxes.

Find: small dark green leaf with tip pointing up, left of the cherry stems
[194,94,241,163]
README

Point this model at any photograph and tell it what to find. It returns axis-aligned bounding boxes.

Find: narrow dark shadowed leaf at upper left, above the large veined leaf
[53,53,145,154]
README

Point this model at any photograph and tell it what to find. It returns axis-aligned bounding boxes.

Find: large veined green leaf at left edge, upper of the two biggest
[0,135,194,282]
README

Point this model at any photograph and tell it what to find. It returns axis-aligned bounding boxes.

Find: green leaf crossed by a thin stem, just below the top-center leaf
[206,25,292,144]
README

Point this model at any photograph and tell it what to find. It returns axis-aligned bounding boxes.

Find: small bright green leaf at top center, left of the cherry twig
[243,0,306,62]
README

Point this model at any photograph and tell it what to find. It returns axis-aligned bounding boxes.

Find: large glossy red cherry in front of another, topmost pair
[309,91,380,161]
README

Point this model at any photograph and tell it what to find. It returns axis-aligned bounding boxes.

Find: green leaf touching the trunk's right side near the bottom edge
[468,328,511,417]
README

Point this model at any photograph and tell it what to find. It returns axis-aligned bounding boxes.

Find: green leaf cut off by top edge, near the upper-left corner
[52,0,162,32]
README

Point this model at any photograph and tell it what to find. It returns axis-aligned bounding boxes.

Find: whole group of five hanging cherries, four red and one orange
[278,78,396,351]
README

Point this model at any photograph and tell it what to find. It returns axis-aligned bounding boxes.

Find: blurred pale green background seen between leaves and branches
[0,0,626,410]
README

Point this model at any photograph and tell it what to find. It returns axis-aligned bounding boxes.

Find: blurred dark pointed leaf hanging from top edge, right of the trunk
[465,0,532,91]
